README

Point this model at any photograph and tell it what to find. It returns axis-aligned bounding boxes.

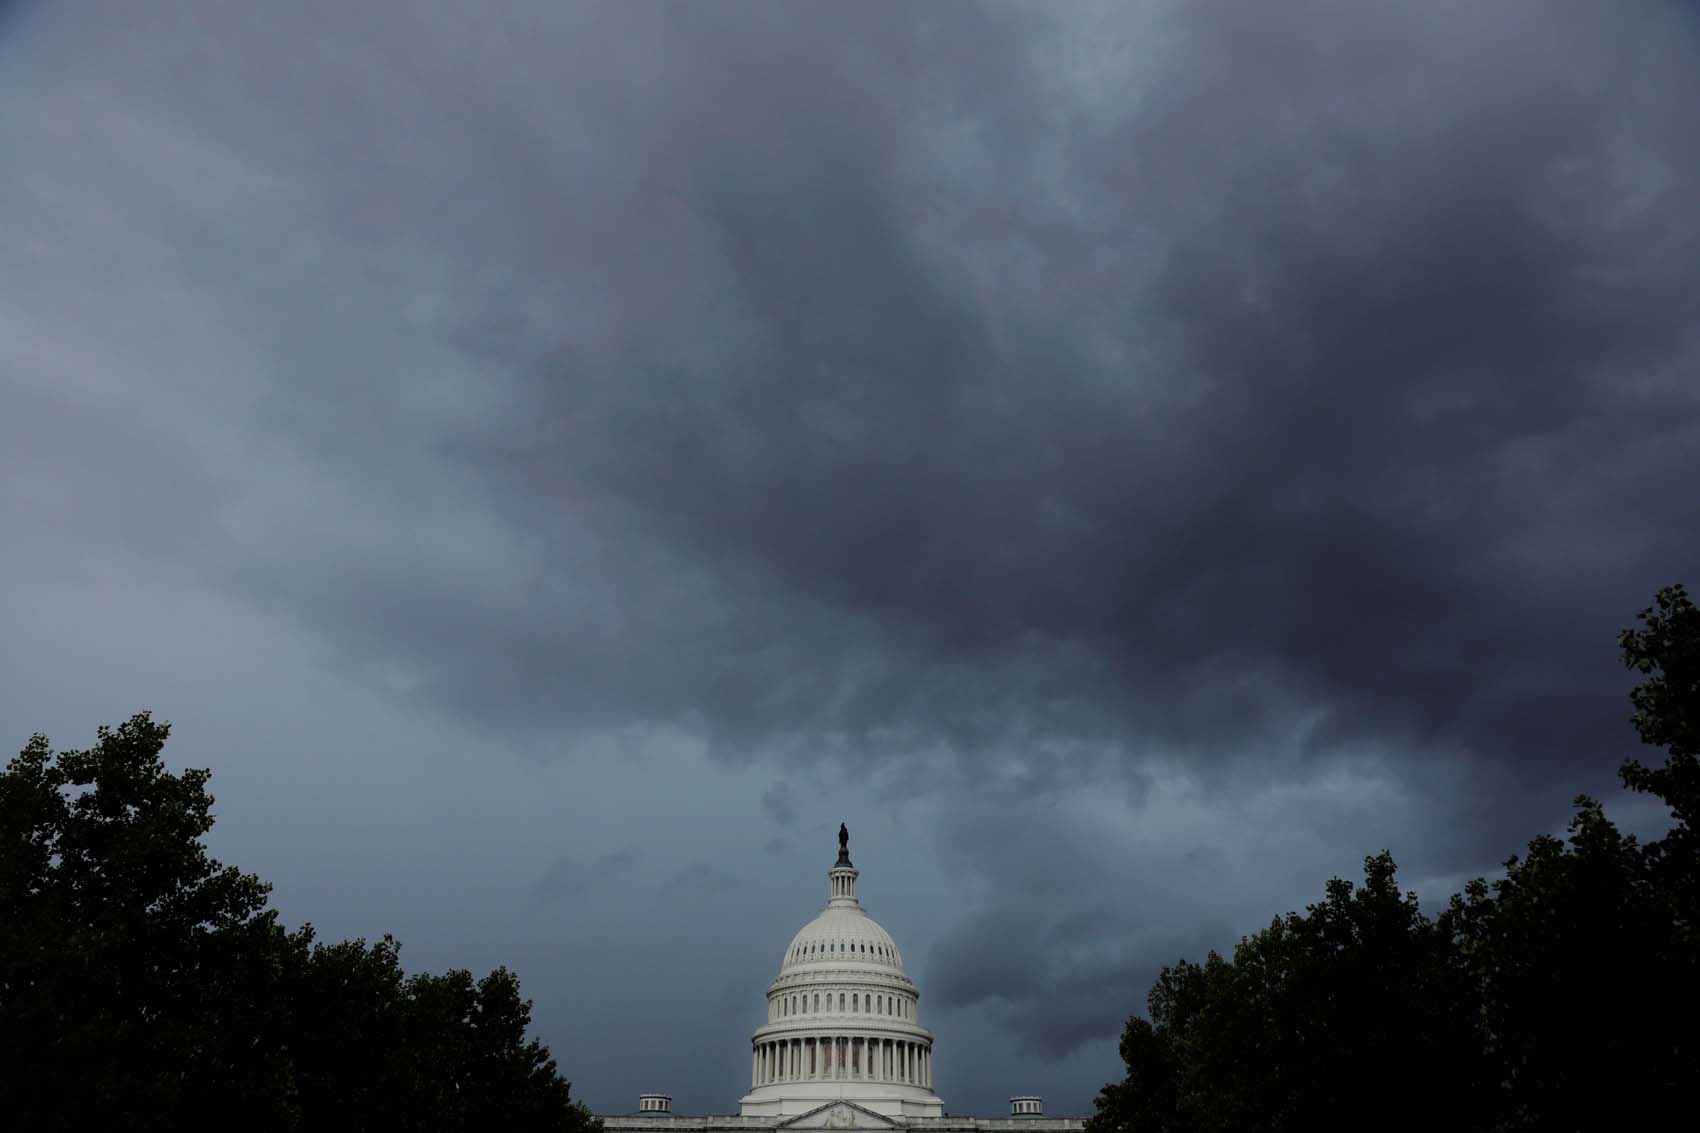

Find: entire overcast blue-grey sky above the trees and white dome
[0,0,1700,1114]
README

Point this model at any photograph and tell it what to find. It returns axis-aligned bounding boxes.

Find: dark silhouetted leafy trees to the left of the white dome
[0,715,598,1133]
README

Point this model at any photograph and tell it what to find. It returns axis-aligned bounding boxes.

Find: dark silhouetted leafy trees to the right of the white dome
[1091,587,1700,1133]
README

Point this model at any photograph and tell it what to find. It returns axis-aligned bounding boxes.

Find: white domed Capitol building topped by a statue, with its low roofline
[602,825,1085,1133]
